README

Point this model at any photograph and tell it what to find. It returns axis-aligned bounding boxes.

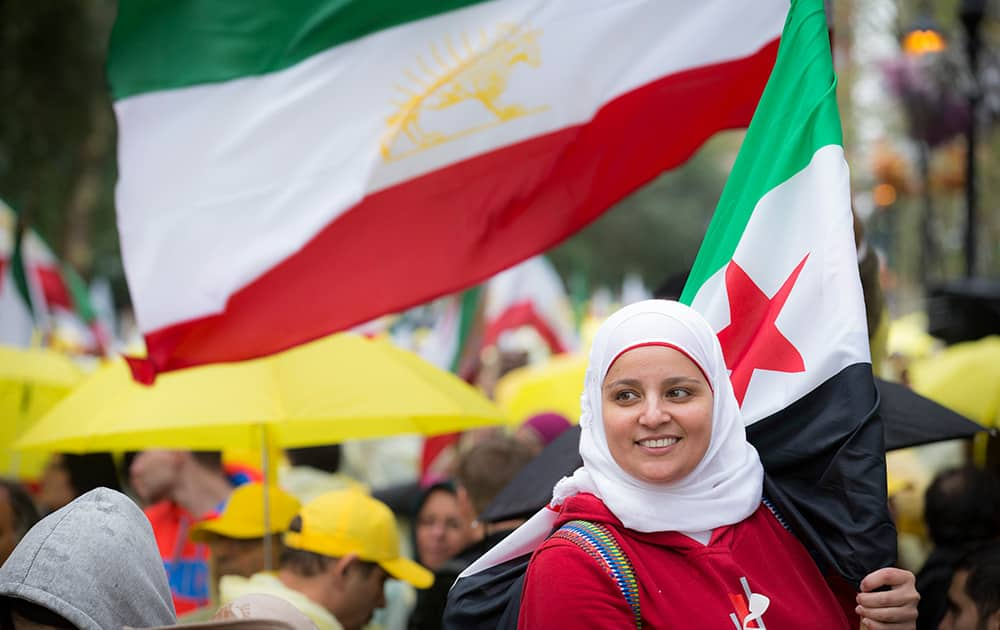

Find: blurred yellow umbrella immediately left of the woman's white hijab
[493,354,587,423]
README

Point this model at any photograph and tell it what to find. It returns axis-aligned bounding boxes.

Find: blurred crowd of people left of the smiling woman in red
[0,422,570,630]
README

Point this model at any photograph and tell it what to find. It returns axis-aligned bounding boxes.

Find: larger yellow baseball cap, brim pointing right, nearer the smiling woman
[284,488,434,588]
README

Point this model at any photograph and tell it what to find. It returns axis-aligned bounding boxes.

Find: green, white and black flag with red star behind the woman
[681,0,896,585]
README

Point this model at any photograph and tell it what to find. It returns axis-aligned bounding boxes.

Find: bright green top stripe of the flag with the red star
[680,0,843,304]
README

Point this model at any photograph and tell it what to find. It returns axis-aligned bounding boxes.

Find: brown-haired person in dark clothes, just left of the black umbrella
[409,435,532,630]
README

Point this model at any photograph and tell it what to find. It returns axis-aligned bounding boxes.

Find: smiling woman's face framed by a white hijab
[601,346,713,483]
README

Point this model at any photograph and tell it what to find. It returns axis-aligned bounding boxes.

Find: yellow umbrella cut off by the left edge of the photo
[0,346,83,479]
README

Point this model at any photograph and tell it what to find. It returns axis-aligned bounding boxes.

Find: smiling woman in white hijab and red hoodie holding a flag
[484,300,918,630]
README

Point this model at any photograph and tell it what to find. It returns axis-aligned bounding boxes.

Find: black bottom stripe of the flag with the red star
[747,363,896,586]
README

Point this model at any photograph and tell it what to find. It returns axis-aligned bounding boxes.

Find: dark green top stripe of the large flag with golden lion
[108,0,492,100]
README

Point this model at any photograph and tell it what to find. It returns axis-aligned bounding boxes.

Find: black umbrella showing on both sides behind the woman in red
[479,379,986,523]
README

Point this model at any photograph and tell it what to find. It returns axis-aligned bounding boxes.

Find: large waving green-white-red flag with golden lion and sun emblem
[108,0,788,379]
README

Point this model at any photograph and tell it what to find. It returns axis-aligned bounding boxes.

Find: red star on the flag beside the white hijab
[719,254,809,406]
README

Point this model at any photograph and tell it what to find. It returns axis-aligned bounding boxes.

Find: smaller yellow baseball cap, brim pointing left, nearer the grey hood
[191,483,301,542]
